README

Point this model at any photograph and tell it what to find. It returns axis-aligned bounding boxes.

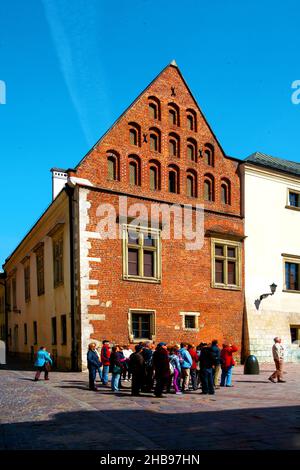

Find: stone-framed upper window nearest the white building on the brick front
[212,239,241,288]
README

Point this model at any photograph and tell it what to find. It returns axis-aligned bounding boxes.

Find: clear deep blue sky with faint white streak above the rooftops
[0,0,300,263]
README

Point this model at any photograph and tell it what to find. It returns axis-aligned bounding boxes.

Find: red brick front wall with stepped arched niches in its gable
[73,65,244,356]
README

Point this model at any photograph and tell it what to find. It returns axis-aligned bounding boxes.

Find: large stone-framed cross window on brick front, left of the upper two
[123,225,161,282]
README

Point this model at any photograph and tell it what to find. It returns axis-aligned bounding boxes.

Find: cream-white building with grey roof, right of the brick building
[241,153,300,362]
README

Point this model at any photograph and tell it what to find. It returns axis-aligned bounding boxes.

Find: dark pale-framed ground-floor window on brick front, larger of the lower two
[129,310,155,341]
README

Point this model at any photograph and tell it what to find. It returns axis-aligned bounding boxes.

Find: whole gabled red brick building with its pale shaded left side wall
[4,62,244,370]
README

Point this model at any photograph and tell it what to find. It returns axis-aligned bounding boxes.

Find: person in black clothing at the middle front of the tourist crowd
[153,343,170,398]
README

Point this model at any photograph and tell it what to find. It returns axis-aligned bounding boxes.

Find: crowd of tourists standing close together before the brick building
[87,340,238,397]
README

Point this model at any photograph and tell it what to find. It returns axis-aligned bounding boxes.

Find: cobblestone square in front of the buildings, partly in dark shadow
[0,364,300,451]
